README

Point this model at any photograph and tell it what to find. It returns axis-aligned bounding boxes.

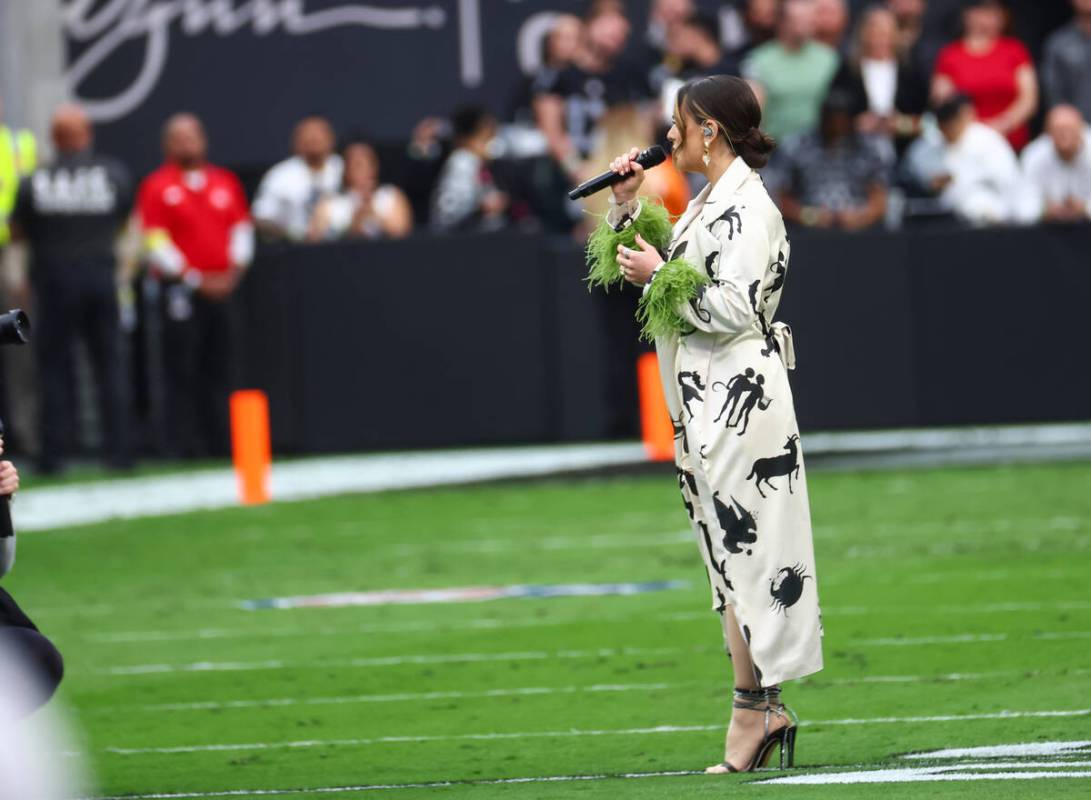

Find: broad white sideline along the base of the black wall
[12,422,1091,532]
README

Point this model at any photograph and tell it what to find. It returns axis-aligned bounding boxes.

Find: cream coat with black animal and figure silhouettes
[608,158,823,685]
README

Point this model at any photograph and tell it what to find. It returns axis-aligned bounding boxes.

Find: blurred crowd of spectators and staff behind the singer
[0,0,1091,470]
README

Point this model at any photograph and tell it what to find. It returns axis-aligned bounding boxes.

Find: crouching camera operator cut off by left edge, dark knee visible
[0,439,64,715]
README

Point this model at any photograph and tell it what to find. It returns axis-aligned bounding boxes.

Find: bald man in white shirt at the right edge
[1022,106,1091,222]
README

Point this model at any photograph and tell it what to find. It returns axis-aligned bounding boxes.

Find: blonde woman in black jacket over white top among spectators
[834,5,928,154]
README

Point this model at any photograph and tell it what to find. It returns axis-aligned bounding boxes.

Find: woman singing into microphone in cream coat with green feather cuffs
[588,75,823,773]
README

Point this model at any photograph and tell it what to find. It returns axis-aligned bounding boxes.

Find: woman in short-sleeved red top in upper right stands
[932,0,1038,151]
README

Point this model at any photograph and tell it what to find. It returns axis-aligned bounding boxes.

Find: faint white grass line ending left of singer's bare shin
[98,647,702,676]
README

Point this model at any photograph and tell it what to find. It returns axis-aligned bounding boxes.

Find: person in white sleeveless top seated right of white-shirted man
[307,142,412,241]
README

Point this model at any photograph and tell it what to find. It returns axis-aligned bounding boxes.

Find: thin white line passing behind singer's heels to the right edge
[104,708,1091,755]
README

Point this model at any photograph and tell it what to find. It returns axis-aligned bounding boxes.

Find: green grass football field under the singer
[4,464,1091,800]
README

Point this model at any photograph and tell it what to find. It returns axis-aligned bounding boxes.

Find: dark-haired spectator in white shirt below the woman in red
[906,95,1019,225]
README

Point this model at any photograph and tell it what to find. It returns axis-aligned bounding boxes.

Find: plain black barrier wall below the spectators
[239,226,1091,452]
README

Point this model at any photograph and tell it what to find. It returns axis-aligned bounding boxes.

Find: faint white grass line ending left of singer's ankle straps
[132,683,685,712]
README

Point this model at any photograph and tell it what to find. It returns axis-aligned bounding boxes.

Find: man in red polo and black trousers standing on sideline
[137,114,254,456]
